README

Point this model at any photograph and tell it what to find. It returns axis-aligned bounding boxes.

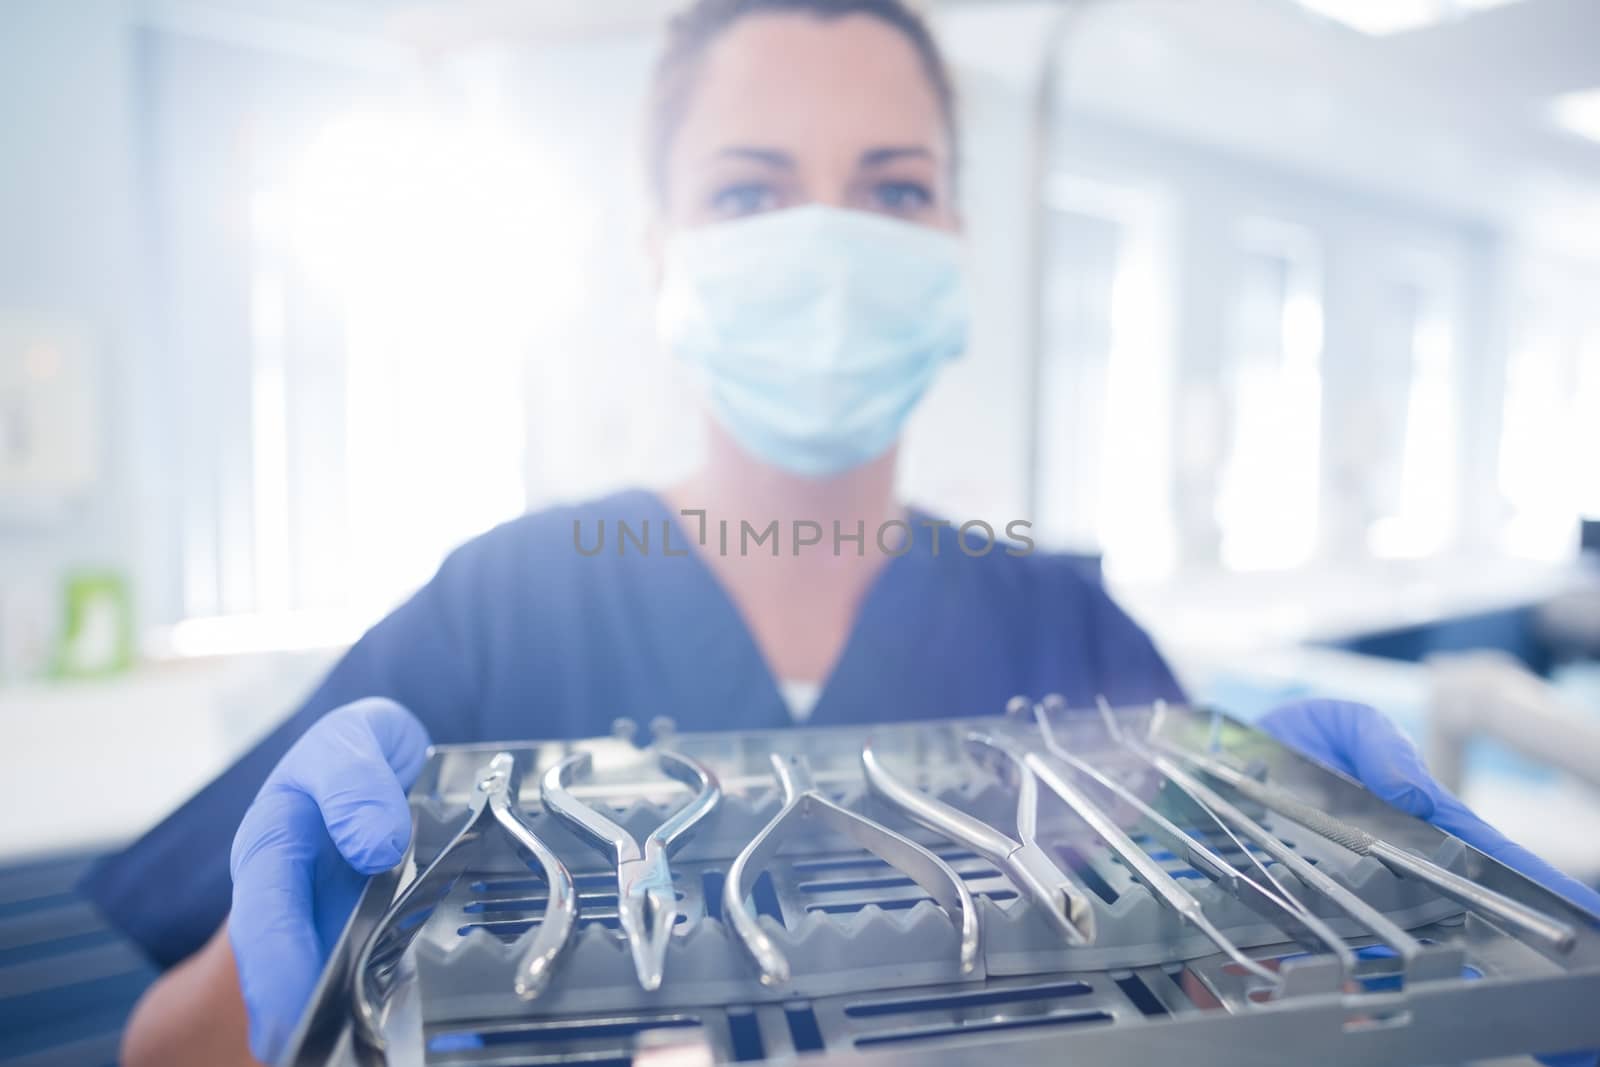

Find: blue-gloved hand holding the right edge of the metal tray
[1256,701,1600,1067]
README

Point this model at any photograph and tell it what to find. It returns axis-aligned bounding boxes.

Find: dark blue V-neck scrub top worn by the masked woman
[85,490,1182,966]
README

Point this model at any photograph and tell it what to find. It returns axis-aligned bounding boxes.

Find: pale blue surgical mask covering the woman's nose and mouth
[656,205,968,477]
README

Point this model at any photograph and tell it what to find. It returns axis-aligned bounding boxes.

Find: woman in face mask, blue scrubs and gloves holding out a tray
[103,0,1600,1067]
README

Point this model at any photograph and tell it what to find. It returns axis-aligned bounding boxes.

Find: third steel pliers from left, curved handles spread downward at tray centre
[722,752,978,985]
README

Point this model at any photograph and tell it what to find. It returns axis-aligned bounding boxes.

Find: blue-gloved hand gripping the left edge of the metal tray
[227,697,429,1064]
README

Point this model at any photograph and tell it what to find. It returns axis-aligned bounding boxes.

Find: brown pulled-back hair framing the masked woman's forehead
[645,0,957,202]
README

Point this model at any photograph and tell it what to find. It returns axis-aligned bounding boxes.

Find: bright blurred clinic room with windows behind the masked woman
[0,0,1600,1062]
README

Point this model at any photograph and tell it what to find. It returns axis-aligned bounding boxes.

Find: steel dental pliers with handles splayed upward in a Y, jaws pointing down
[539,750,722,992]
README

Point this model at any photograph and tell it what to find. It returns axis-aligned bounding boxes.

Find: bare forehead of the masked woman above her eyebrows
[672,13,946,158]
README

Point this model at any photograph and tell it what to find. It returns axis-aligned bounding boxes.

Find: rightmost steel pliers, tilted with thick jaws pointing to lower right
[861,734,1094,945]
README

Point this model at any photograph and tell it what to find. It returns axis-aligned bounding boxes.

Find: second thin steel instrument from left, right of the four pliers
[1006,696,1355,971]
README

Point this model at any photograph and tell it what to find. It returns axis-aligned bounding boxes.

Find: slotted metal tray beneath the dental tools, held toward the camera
[285,709,1600,1067]
